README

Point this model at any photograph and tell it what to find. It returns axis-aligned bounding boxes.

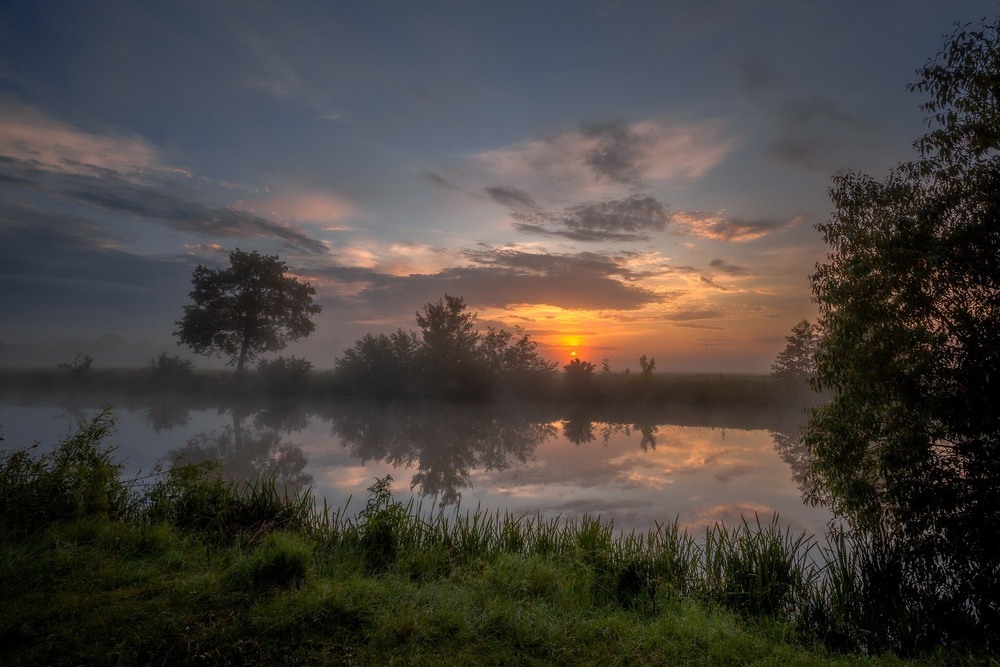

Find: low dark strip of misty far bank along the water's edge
[0,366,824,407]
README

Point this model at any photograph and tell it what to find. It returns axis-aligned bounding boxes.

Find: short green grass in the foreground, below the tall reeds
[0,519,942,665]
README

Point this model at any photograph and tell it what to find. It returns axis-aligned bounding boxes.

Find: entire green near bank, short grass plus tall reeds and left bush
[0,413,976,665]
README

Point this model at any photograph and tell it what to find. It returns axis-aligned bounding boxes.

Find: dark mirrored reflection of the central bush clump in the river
[331,404,555,506]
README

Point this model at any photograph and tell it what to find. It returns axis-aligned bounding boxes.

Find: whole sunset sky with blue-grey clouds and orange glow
[0,0,998,372]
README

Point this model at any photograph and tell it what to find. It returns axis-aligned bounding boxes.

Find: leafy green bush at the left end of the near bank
[0,409,130,532]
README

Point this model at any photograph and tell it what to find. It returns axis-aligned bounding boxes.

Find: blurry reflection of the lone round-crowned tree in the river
[168,410,312,494]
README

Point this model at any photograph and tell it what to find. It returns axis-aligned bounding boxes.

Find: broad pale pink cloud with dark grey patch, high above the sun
[455,120,733,201]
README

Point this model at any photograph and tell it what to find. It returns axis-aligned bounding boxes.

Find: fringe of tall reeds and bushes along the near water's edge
[0,411,984,664]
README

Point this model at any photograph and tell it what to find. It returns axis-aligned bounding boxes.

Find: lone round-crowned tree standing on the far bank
[174,249,320,376]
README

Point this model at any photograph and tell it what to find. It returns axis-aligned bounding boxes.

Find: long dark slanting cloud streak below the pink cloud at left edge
[0,158,327,254]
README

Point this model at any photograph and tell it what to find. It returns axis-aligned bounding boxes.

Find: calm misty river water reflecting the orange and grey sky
[0,402,831,535]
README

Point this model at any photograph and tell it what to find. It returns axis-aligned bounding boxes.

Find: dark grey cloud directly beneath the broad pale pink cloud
[512,195,669,241]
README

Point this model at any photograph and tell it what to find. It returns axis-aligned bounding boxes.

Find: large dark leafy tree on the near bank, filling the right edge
[805,19,1000,647]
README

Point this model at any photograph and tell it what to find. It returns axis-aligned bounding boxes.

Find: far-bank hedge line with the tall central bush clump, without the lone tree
[0,295,810,406]
